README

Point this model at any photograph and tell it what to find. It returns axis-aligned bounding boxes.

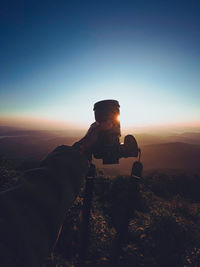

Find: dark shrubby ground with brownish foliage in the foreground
[0,157,200,267]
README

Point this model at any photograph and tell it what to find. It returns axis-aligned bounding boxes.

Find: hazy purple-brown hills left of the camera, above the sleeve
[0,127,75,164]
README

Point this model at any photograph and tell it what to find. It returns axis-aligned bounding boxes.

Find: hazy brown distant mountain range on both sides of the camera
[0,126,200,175]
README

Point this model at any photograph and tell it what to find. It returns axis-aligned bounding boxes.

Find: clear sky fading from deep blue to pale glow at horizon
[0,0,200,131]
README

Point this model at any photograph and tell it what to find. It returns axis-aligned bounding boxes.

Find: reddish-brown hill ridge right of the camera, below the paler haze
[115,142,200,176]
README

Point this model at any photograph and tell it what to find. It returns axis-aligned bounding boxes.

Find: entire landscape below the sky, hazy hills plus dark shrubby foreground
[0,127,200,267]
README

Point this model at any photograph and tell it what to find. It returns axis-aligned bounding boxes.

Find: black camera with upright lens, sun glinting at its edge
[92,100,139,164]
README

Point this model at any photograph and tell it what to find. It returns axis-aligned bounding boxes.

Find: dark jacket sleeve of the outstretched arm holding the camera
[0,146,88,267]
